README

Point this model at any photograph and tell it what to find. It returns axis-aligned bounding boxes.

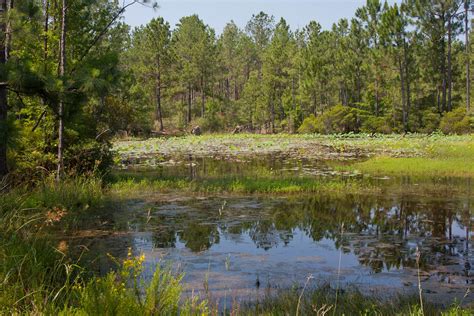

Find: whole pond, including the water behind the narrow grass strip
[66,156,474,305]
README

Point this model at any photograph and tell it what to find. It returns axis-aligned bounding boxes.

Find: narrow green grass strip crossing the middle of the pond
[107,174,471,199]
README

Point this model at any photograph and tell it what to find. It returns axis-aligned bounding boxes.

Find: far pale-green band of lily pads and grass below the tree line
[114,134,474,158]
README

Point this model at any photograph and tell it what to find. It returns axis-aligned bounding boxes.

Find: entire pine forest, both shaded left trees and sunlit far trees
[0,0,474,177]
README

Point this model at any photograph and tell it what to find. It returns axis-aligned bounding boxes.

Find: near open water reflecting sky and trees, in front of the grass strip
[67,193,474,306]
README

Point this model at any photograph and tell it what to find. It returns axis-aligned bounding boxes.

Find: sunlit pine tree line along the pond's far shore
[122,0,472,133]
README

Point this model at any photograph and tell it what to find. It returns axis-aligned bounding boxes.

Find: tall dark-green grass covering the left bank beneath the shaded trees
[0,179,102,313]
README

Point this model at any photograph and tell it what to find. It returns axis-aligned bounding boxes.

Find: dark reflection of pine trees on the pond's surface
[143,191,472,272]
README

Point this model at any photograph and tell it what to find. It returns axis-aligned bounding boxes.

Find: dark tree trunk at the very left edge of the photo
[0,0,8,176]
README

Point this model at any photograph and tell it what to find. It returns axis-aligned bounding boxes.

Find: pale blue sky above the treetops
[125,0,400,33]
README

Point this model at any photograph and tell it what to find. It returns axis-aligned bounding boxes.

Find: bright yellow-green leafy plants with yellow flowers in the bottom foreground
[70,253,185,315]
